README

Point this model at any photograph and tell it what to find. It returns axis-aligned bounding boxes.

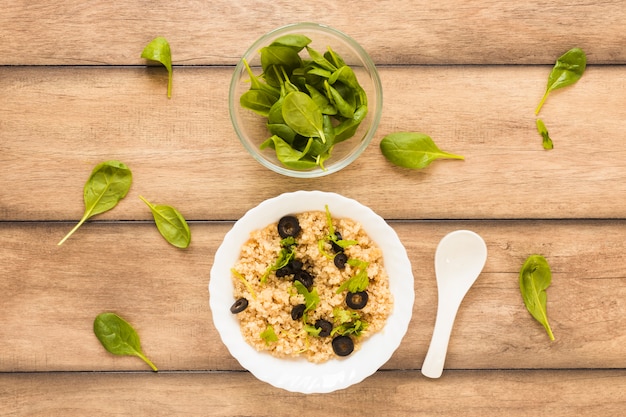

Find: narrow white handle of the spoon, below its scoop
[422,305,459,378]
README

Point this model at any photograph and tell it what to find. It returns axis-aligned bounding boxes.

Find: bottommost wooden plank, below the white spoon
[0,370,626,417]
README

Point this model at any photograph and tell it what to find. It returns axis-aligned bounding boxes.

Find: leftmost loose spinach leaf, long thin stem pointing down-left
[59,161,133,245]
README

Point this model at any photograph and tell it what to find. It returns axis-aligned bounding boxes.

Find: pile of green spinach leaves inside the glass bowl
[240,34,368,170]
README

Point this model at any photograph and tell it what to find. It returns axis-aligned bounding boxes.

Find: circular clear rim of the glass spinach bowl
[228,22,383,178]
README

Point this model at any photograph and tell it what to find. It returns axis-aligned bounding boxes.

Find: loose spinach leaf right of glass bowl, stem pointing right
[380,132,465,169]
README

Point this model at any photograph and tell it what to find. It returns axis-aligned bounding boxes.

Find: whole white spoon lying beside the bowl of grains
[422,230,487,378]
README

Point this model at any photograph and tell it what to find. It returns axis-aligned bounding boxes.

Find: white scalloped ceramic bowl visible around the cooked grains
[209,191,414,393]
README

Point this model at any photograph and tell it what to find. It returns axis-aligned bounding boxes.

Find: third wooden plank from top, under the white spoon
[0,220,626,372]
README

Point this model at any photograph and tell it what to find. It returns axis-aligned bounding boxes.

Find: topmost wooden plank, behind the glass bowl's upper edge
[0,0,626,65]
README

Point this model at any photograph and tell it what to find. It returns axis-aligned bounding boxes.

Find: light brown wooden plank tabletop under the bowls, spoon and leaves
[0,0,626,416]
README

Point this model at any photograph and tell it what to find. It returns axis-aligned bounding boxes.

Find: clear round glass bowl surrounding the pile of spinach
[229,23,383,178]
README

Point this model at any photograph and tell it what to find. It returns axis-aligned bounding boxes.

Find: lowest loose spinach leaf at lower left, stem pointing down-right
[93,313,158,372]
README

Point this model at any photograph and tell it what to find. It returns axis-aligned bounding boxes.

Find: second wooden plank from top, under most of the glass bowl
[0,66,626,220]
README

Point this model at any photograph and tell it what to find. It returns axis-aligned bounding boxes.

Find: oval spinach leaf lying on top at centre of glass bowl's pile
[282,91,326,142]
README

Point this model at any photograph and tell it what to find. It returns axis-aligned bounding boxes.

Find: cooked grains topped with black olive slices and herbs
[231,207,393,363]
